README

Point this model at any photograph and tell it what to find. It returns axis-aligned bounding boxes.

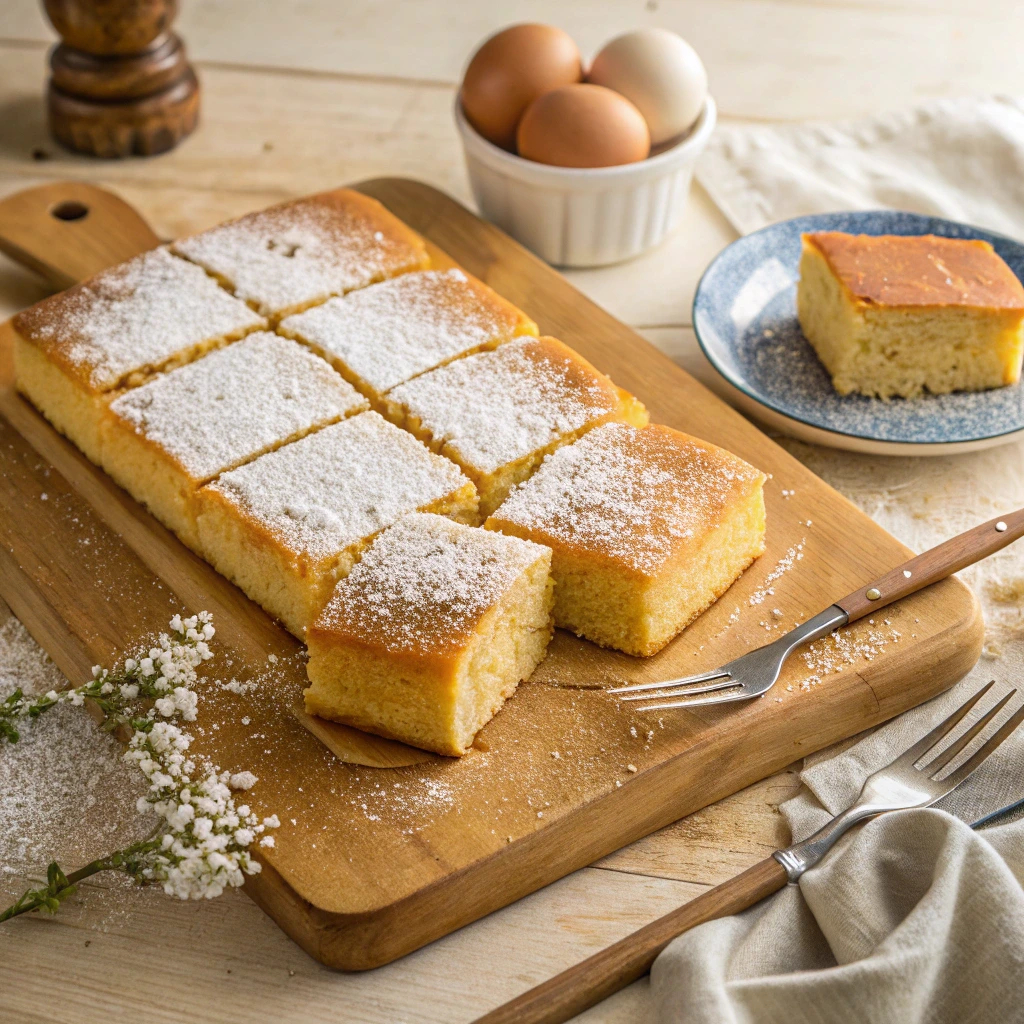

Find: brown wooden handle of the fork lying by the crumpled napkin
[475,857,786,1024]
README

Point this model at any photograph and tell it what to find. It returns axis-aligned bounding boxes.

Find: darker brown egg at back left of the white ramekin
[462,25,583,150]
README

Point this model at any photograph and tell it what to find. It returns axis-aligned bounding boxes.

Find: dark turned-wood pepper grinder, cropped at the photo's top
[43,0,199,157]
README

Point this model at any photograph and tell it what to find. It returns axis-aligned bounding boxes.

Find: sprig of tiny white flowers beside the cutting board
[0,611,281,922]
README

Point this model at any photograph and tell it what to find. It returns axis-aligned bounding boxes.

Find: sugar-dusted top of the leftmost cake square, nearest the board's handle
[14,249,265,391]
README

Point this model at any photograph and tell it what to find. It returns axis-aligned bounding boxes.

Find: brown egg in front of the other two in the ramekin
[516,85,650,167]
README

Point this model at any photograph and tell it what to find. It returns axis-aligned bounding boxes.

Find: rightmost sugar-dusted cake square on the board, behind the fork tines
[485,423,765,655]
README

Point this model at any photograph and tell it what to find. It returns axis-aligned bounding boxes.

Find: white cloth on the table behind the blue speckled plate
[696,96,1024,239]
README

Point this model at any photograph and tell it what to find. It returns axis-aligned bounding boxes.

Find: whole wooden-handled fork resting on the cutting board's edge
[606,509,1024,711]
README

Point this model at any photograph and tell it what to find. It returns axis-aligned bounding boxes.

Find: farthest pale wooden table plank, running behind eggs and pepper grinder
[0,0,1024,118]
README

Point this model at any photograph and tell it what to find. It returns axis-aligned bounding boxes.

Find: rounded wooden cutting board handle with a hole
[0,181,160,289]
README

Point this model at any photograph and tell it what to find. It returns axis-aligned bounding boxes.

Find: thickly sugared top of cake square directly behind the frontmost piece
[209,413,468,560]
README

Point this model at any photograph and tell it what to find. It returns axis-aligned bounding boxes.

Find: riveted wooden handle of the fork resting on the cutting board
[836,509,1024,623]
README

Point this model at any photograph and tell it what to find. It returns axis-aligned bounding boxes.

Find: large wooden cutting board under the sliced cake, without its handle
[0,178,982,970]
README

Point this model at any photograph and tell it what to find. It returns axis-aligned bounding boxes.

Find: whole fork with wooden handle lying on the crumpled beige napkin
[475,683,1024,1024]
